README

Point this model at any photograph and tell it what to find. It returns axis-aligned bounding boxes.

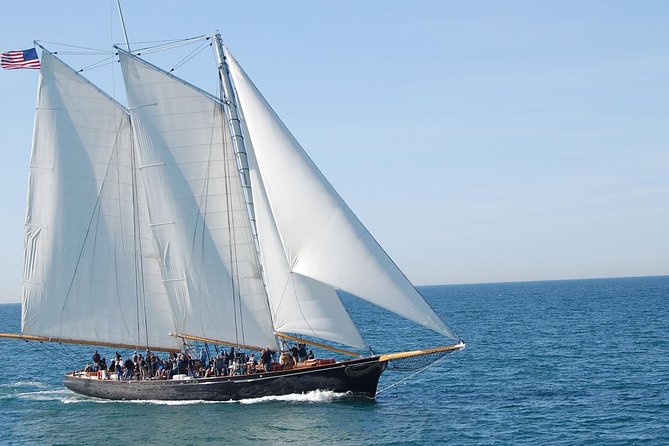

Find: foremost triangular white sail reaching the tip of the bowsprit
[228,50,457,339]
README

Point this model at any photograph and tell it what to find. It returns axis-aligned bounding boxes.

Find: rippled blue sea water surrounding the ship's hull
[0,277,669,445]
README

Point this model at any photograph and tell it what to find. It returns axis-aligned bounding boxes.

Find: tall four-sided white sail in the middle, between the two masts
[119,50,276,347]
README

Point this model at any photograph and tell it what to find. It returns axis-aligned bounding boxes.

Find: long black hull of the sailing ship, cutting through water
[65,357,387,401]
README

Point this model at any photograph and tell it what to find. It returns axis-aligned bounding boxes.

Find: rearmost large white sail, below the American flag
[22,51,178,348]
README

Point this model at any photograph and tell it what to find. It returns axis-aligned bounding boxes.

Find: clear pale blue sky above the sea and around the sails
[0,0,669,303]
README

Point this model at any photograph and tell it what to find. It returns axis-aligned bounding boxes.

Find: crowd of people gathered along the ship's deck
[83,344,314,380]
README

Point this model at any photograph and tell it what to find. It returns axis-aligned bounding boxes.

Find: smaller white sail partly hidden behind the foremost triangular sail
[248,138,367,349]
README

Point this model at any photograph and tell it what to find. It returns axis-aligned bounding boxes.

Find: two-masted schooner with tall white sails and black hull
[0,33,465,400]
